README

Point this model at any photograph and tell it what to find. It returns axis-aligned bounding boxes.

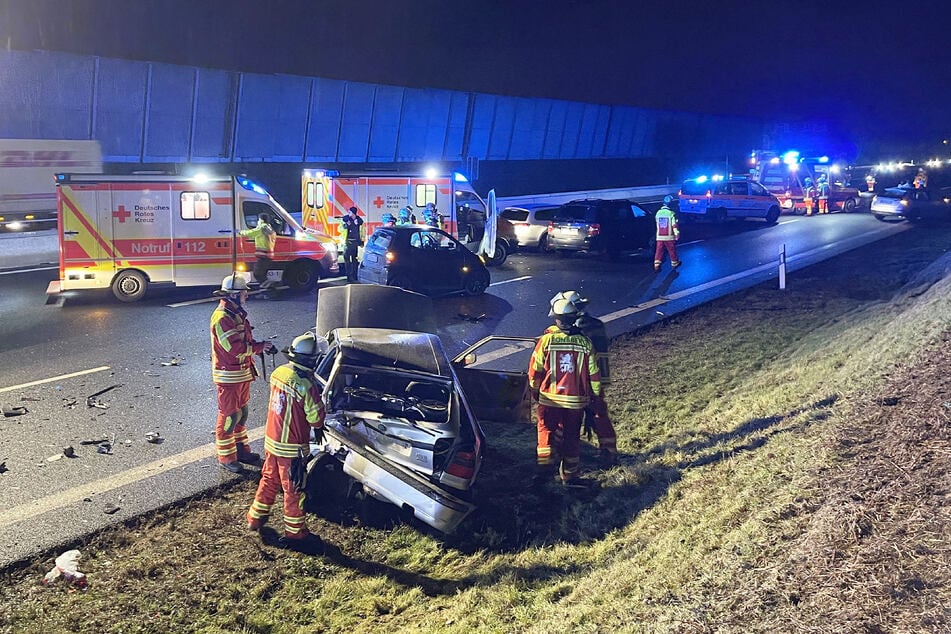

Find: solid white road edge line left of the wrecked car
[0,425,264,530]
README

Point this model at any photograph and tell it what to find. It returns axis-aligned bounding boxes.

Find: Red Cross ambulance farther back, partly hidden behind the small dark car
[301,170,486,242]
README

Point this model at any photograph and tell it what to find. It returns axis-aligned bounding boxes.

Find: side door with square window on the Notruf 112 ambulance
[168,181,234,286]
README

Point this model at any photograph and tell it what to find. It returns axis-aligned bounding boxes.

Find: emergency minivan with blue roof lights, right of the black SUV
[678,176,781,225]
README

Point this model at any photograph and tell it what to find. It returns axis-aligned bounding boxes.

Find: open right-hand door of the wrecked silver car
[452,335,535,423]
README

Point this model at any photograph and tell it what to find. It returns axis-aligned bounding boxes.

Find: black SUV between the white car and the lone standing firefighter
[547,199,655,257]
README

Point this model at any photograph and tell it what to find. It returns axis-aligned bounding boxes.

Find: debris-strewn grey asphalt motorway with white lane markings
[0,213,909,566]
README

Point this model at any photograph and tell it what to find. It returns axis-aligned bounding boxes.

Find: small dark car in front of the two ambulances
[357,225,489,295]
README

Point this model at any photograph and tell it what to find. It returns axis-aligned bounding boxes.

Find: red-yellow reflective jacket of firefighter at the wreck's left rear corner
[264,363,324,458]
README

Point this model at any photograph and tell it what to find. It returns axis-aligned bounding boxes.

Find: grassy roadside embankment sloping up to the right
[0,221,951,632]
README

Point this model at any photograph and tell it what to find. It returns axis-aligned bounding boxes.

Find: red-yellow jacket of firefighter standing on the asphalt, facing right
[209,299,265,384]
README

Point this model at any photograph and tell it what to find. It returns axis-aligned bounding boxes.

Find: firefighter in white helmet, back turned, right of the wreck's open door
[528,299,601,487]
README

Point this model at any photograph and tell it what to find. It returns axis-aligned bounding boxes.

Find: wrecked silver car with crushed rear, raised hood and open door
[305,285,534,533]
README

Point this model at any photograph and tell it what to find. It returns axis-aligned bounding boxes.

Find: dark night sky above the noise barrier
[0,0,951,158]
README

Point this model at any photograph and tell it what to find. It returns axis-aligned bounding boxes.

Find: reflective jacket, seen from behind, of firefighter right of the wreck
[528,326,601,409]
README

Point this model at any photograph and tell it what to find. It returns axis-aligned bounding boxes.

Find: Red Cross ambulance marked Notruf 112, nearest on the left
[46,174,339,302]
